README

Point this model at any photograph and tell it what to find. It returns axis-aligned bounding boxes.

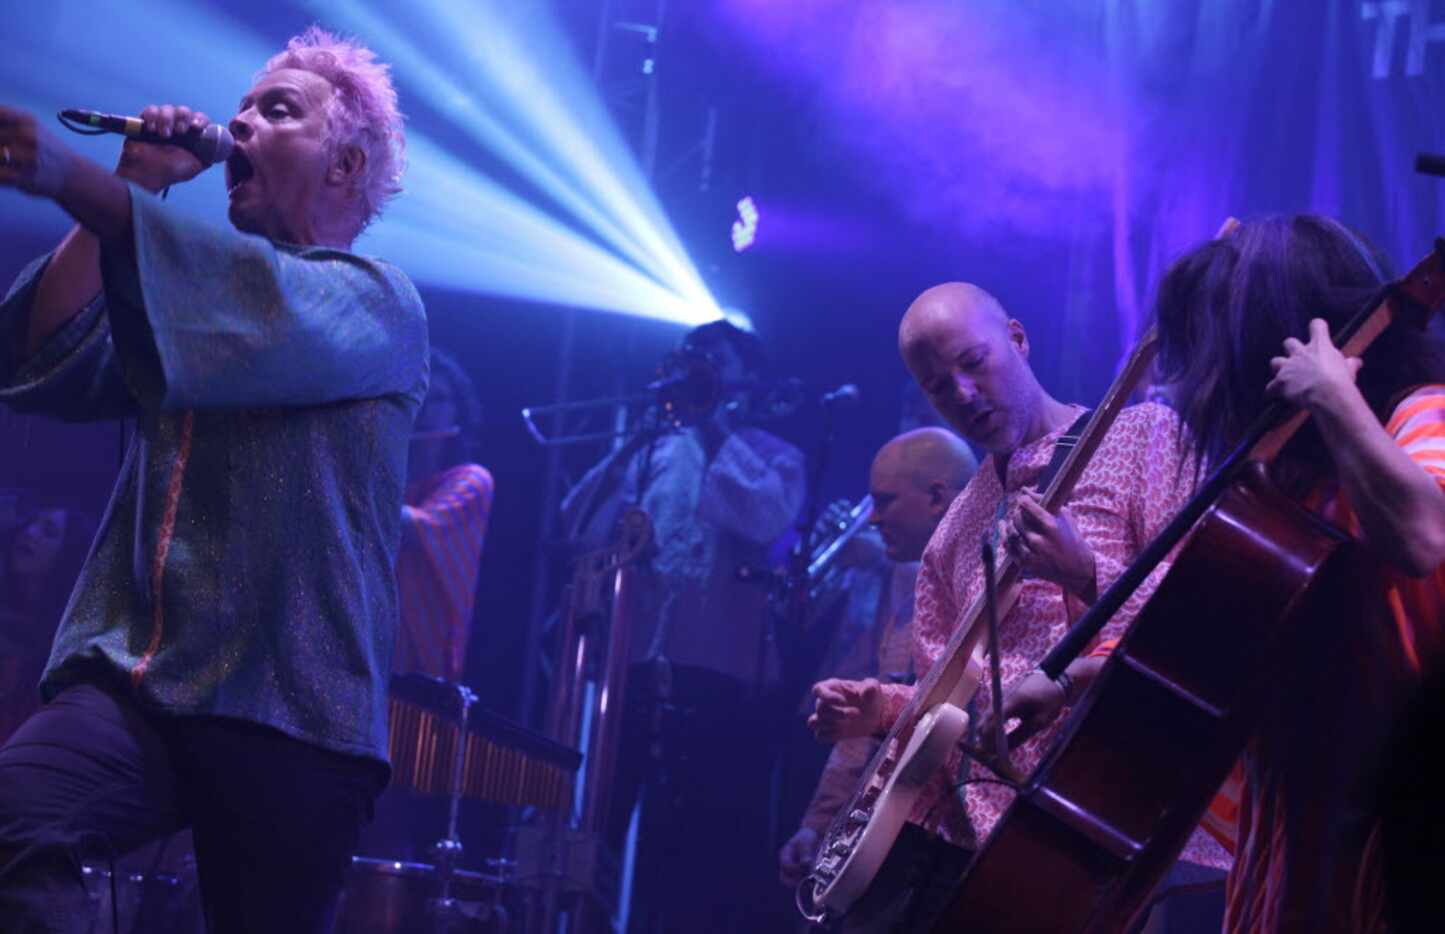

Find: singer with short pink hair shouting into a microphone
[0,27,428,933]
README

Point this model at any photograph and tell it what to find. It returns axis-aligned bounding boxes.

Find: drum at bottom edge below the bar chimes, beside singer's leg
[335,856,507,934]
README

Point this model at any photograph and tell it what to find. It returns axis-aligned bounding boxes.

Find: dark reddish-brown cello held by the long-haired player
[933,240,1445,934]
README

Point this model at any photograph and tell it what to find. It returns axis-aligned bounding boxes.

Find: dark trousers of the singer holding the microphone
[0,685,383,934]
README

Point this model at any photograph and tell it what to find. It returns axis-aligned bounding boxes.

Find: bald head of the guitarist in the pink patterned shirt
[899,282,1048,454]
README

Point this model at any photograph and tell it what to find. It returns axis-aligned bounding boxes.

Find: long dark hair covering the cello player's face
[1155,214,1445,480]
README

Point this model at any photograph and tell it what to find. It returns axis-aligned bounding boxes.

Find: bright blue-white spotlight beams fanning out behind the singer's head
[0,0,721,325]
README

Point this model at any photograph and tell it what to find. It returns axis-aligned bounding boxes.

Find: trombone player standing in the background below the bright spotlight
[562,321,805,931]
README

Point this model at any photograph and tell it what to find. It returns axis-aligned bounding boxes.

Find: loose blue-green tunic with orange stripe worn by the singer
[0,188,428,761]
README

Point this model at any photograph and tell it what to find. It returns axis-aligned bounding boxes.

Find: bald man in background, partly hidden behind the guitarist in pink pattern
[777,428,978,886]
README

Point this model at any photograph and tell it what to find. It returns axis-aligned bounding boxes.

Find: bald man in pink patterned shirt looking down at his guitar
[811,282,1222,931]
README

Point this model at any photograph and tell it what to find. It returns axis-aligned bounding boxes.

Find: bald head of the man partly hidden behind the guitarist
[868,428,978,561]
